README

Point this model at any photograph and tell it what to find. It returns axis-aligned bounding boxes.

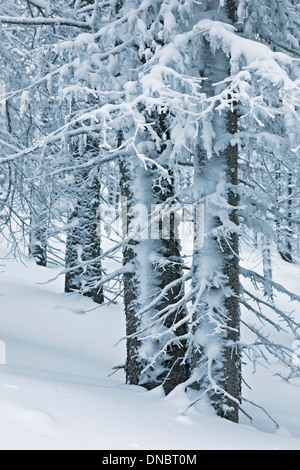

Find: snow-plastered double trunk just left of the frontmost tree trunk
[121,115,188,393]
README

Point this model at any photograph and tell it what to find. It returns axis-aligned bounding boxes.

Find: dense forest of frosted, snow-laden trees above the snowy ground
[0,0,300,430]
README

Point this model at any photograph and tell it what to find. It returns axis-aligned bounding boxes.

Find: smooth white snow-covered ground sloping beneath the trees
[0,244,300,451]
